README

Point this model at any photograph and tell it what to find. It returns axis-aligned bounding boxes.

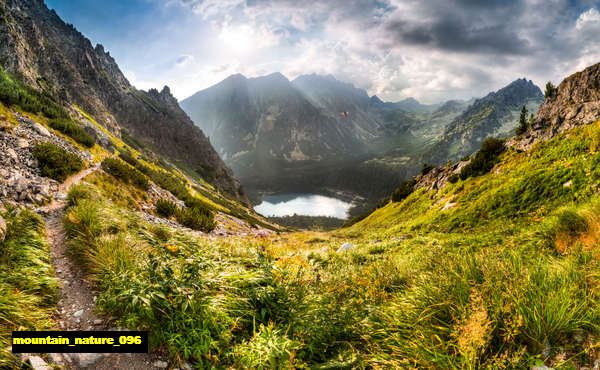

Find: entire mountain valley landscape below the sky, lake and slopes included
[0,0,600,370]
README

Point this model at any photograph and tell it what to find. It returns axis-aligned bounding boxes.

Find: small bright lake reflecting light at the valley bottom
[254,194,352,219]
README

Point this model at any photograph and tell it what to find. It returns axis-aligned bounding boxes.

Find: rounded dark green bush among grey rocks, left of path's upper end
[33,143,84,182]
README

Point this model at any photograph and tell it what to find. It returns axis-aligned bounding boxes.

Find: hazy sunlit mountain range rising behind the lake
[180,73,543,204]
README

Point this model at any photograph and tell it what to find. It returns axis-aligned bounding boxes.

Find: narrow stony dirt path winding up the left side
[33,164,168,369]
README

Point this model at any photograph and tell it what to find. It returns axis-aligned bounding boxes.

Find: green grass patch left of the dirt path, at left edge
[0,208,58,368]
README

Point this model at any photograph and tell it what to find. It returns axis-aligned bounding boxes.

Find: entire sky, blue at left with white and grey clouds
[46,0,600,104]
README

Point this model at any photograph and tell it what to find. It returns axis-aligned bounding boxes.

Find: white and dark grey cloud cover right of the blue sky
[149,0,600,103]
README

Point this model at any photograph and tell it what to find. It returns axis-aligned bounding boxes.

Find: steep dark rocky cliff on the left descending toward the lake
[0,0,245,201]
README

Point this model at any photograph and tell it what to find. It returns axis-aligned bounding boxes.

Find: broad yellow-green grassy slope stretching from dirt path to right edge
[58,123,600,368]
